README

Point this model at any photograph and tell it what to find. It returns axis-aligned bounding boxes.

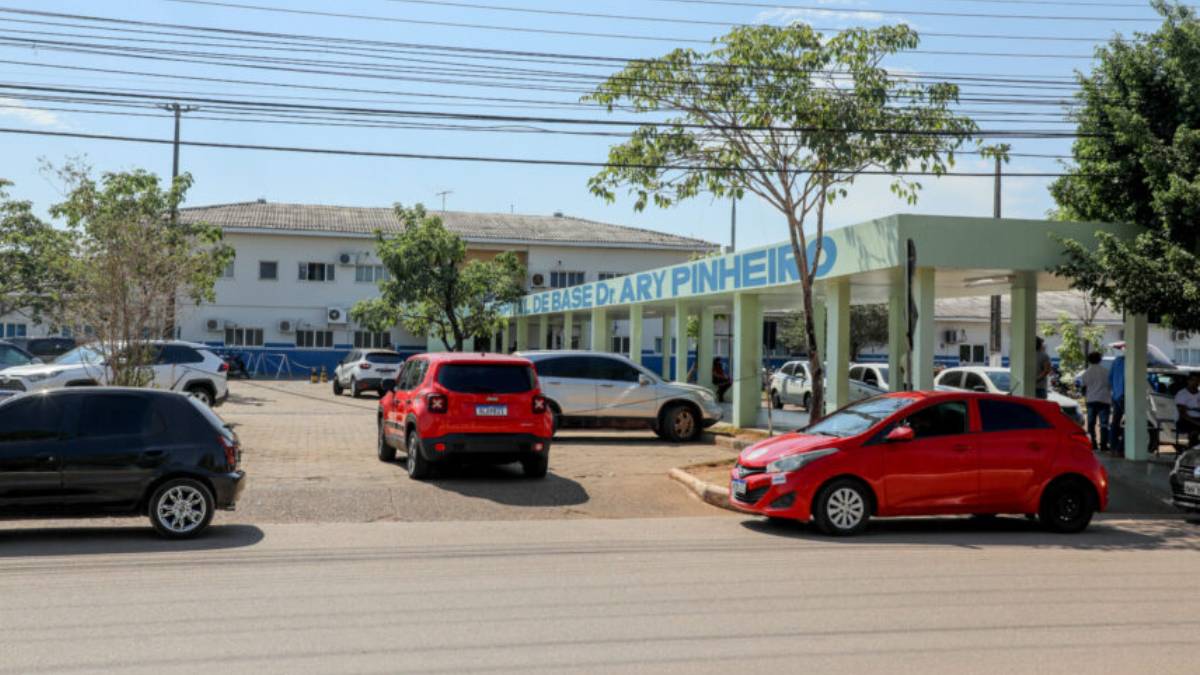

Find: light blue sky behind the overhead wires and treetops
[0,0,1157,247]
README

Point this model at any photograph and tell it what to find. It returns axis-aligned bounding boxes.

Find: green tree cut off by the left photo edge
[0,180,72,322]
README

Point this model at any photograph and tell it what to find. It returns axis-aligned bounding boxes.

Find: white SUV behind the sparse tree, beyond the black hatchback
[0,340,229,406]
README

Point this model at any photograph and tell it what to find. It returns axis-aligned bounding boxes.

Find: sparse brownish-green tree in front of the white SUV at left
[50,162,234,386]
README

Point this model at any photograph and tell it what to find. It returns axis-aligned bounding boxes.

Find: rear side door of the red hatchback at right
[976,399,1057,513]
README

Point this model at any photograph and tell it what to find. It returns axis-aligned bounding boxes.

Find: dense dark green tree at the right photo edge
[1050,0,1200,330]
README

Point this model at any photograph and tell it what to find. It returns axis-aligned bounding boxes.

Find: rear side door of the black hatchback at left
[62,390,170,508]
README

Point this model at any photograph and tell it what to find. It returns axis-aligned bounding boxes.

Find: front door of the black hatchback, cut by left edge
[0,396,70,512]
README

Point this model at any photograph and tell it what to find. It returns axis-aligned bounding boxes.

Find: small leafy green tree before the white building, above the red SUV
[350,204,526,352]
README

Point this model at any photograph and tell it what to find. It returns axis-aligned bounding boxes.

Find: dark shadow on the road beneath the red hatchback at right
[742,516,1200,551]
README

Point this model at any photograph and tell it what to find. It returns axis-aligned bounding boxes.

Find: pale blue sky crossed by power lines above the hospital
[0,0,1159,249]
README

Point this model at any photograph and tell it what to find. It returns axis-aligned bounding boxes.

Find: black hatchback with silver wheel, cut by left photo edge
[0,387,245,538]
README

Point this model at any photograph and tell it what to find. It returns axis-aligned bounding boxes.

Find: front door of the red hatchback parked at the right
[883,399,979,515]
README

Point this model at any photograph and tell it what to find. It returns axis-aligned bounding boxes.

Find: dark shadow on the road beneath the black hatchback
[0,525,263,560]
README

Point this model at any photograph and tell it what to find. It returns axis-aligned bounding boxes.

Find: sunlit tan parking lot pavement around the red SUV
[217,381,731,522]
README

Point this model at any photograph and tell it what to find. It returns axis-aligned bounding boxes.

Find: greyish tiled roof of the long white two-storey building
[179,202,716,251]
